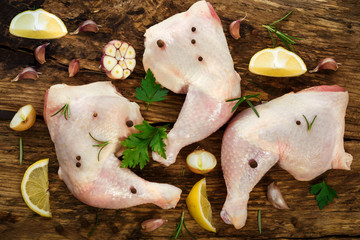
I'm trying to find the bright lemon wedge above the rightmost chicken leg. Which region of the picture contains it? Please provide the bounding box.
[249,47,307,77]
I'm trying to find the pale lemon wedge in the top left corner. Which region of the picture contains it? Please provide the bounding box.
[9,8,67,39]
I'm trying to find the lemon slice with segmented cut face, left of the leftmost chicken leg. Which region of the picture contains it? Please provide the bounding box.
[21,158,52,217]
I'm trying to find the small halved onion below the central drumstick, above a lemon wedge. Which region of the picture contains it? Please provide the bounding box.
[186,150,217,174]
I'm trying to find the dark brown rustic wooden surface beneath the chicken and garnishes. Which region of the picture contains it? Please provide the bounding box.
[0,0,360,239]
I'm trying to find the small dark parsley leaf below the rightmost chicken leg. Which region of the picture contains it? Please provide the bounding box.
[310,181,338,210]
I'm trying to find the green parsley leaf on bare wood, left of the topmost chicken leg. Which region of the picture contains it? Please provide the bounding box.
[135,68,169,110]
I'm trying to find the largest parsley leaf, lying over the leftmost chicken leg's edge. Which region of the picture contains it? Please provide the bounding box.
[120,120,167,169]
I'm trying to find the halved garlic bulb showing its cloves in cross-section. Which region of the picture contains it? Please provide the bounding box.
[101,40,136,79]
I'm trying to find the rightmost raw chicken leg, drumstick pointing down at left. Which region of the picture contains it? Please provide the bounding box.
[221,86,352,229]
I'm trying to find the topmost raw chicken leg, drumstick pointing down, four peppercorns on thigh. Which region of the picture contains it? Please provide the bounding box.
[143,1,240,166]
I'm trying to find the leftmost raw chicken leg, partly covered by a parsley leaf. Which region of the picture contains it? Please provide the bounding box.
[44,82,181,209]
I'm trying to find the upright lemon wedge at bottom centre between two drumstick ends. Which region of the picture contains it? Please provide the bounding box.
[186,178,216,232]
